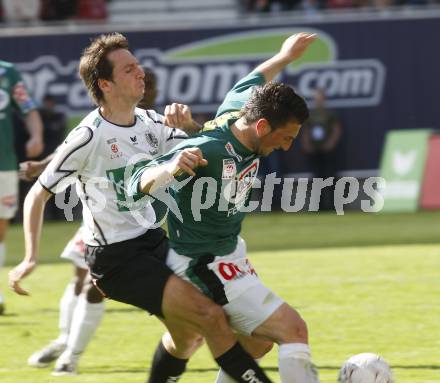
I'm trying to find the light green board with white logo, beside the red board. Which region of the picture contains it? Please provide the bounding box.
[381,129,431,212]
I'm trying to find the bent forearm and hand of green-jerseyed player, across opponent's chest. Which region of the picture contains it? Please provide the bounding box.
[138,148,208,193]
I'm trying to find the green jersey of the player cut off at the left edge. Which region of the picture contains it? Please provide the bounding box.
[0,61,35,171]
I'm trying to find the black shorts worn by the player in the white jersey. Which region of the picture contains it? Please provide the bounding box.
[85,228,173,317]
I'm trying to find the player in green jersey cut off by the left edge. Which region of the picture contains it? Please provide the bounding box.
[0,61,43,315]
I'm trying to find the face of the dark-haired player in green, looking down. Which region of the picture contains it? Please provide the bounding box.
[257,121,301,156]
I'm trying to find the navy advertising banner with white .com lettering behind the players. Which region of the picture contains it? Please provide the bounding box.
[0,18,440,173]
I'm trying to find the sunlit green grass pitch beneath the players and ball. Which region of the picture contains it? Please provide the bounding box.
[0,212,440,383]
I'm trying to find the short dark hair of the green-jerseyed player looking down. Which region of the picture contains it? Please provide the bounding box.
[240,81,309,129]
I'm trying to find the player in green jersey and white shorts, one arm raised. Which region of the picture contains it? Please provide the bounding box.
[130,33,318,383]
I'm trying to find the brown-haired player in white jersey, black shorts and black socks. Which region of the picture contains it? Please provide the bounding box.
[9,33,270,383]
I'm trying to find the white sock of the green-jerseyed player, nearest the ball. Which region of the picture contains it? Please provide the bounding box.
[278,343,319,383]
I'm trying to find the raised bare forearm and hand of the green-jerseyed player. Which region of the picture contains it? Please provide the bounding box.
[255,32,317,81]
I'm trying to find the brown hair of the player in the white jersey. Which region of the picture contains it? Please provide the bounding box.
[79,33,128,105]
